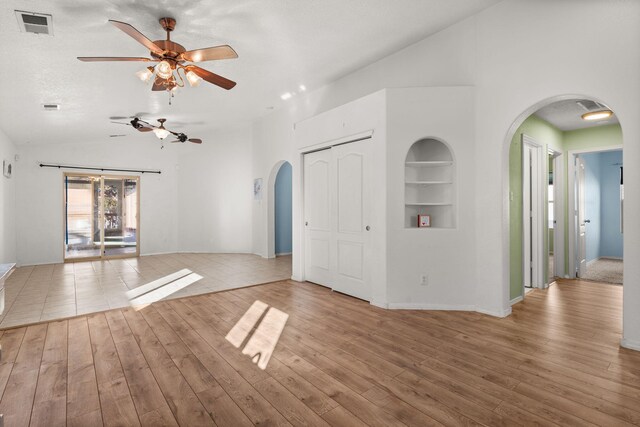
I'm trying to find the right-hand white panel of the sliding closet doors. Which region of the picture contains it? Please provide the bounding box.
[331,141,371,301]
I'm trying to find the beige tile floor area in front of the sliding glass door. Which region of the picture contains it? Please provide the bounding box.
[0,254,291,328]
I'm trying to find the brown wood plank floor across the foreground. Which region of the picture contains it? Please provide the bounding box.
[0,281,640,427]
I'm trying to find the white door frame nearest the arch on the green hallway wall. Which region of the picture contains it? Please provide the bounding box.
[522,134,548,296]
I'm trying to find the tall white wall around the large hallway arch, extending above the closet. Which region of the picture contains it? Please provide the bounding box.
[253,0,640,348]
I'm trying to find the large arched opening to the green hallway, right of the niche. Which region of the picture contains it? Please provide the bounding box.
[507,96,624,304]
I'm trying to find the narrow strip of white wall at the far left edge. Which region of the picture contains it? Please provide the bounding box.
[0,130,17,264]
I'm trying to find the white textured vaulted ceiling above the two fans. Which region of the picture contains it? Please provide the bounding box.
[0,0,498,145]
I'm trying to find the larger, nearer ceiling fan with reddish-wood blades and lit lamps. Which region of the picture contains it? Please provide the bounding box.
[78,18,238,91]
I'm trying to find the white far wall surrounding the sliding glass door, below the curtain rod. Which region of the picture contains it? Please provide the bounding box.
[16,123,251,265]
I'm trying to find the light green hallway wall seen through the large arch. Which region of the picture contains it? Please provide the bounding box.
[509,119,622,300]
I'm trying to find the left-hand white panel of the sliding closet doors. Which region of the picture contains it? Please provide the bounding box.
[304,149,333,286]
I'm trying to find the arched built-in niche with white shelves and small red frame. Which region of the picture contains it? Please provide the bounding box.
[404,138,456,228]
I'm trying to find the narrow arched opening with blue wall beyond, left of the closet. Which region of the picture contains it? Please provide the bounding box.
[266,160,293,258]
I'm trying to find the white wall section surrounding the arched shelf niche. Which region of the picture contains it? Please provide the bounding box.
[386,87,476,314]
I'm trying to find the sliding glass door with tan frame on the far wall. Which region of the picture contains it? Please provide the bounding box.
[64,174,140,260]
